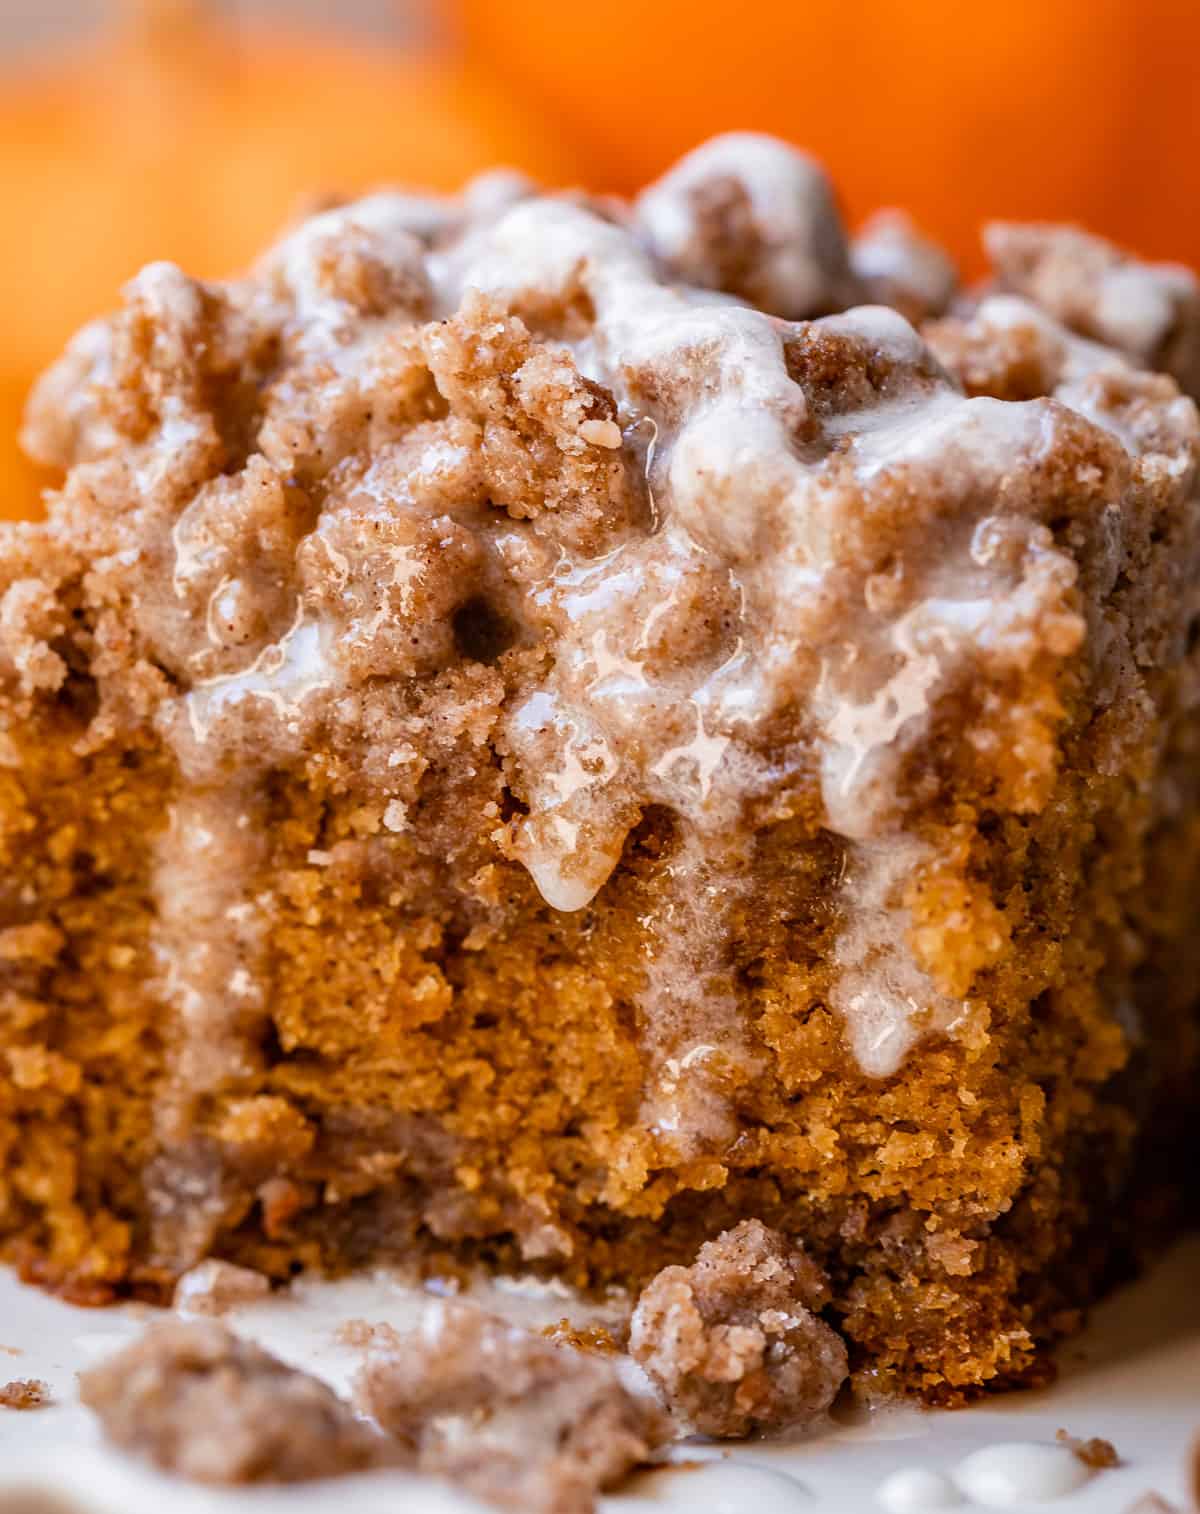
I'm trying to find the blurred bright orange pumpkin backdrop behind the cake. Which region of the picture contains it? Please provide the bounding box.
[0,0,1200,513]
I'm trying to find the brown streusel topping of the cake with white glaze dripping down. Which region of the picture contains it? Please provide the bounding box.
[3,136,1197,1131]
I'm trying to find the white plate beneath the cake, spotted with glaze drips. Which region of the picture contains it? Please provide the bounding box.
[0,1238,1200,1514]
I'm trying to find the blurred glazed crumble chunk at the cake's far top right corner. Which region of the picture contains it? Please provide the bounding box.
[984,221,1200,394]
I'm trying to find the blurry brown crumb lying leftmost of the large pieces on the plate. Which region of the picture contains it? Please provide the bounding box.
[79,1320,385,1484]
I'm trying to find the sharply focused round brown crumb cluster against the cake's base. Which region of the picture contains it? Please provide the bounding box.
[630,1220,849,1437]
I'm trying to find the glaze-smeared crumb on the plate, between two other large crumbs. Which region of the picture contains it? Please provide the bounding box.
[357,1299,669,1514]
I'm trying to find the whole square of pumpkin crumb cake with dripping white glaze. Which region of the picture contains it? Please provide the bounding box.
[0,136,1200,1400]
